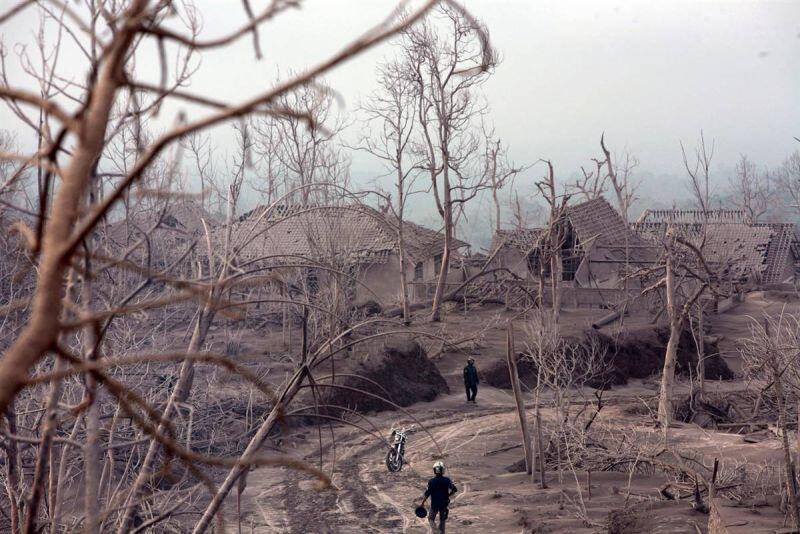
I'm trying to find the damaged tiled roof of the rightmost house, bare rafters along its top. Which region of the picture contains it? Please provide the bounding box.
[633,210,800,287]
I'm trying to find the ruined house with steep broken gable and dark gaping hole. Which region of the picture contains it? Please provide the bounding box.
[491,197,655,288]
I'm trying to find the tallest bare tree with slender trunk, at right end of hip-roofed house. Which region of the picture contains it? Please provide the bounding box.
[403,5,496,321]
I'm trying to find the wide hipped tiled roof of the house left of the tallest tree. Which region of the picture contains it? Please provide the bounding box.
[220,204,467,263]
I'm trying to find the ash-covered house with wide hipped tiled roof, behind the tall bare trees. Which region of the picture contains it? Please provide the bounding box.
[220,204,468,306]
